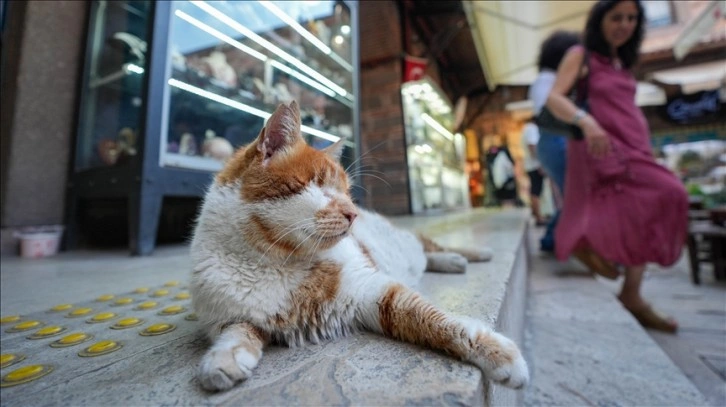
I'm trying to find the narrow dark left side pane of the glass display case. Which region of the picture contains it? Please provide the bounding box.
[75,1,151,171]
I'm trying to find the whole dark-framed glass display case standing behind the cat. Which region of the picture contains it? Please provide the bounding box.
[66,0,359,255]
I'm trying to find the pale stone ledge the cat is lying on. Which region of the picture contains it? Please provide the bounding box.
[0,210,527,405]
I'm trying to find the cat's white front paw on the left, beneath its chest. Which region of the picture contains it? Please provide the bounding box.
[197,347,259,391]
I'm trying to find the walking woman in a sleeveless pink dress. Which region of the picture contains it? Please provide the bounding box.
[547,0,688,332]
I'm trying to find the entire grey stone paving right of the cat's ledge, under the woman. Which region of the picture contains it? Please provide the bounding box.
[525,229,726,406]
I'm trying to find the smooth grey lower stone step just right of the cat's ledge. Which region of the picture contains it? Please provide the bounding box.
[524,232,707,406]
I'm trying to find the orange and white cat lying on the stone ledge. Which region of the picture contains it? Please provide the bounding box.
[191,102,529,390]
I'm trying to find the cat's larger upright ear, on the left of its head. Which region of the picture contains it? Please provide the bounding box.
[257,100,304,164]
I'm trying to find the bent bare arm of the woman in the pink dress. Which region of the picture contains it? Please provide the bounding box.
[547,47,610,157]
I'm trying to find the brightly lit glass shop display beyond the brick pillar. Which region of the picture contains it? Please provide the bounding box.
[401,78,470,213]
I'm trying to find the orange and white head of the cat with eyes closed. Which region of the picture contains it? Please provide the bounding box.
[217,102,358,254]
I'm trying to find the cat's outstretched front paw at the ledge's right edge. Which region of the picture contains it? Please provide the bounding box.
[470,328,529,389]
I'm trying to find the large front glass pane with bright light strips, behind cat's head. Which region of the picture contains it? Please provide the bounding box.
[160,1,356,171]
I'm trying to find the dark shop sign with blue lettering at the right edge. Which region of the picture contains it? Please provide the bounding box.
[664,89,722,124]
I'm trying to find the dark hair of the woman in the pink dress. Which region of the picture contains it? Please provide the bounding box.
[585,0,645,68]
